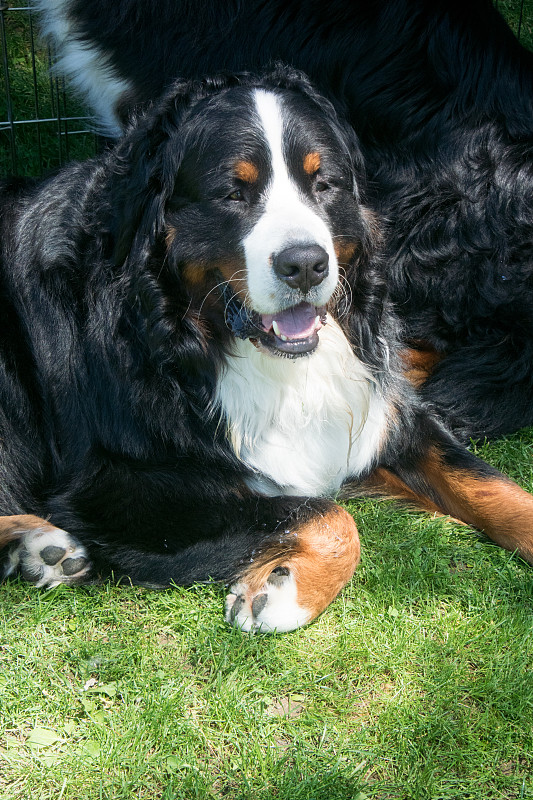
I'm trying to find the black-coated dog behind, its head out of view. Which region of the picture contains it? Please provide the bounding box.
[37,0,533,441]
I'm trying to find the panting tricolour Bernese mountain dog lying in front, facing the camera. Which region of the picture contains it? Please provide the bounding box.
[0,68,533,631]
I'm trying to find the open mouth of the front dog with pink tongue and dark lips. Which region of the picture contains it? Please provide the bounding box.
[222,290,327,358]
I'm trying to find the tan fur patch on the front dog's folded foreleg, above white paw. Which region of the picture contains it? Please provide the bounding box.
[235,503,361,619]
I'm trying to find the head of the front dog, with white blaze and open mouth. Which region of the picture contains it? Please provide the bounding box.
[113,69,378,357]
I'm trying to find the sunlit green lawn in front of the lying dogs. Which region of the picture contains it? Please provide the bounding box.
[0,0,533,800]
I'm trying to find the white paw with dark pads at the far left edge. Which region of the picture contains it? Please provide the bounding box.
[9,525,91,589]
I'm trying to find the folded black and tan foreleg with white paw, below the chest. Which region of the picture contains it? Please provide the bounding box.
[87,496,360,632]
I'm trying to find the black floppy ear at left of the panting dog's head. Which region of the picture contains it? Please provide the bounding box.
[111,75,245,264]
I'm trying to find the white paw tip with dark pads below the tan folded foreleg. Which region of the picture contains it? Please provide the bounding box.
[225,567,313,633]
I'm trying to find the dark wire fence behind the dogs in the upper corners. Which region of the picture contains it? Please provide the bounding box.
[0,0,533,175]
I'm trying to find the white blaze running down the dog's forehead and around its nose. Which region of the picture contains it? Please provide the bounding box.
[244,89,338,313]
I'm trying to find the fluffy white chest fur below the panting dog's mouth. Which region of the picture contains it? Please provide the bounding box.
[216,320,387,497]
